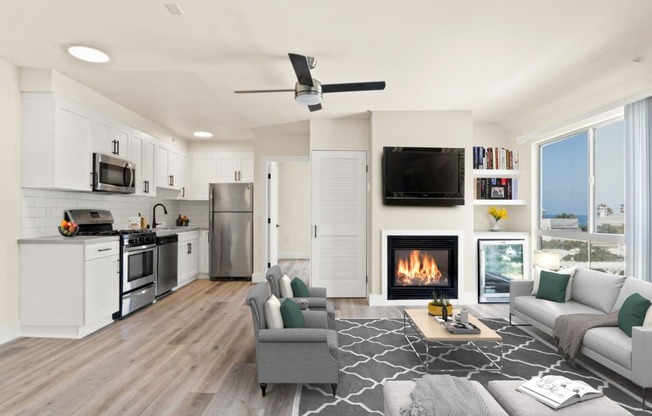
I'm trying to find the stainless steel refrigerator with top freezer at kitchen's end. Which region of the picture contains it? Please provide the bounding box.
[208,183,254,280]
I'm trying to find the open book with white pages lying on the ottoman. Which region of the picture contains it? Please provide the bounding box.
[516,376,603,409]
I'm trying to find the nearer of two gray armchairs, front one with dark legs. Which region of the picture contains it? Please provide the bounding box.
[247,283,339,396]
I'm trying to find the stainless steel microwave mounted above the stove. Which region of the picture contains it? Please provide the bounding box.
[93,153,136,194]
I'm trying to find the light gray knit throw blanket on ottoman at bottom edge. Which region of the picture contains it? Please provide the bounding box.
[401,374,489,416]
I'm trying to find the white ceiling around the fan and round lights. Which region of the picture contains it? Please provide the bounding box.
[0,0,652,139]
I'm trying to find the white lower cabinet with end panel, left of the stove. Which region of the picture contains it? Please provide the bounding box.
[20,239,120,338]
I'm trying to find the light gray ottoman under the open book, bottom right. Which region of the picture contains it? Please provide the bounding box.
[487,380,631,416]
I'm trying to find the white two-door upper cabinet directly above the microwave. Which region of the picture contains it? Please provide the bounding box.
[91,113,131,163]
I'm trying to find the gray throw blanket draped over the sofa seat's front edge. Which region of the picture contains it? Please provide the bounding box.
[552,311,618,365]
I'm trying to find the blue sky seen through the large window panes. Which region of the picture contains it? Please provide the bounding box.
[541,122,624,215]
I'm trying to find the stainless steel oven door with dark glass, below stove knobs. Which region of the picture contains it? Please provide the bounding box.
[122,244,157,294]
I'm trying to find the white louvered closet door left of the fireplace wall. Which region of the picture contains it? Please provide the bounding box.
[310,151,367,297]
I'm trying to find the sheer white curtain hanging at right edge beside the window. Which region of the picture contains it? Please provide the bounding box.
[625,97,652,281]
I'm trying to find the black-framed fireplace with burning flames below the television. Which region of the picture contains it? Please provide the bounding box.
[387,235,458,300]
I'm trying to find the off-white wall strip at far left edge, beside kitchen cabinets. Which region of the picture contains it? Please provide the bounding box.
[0,59,20,344]
